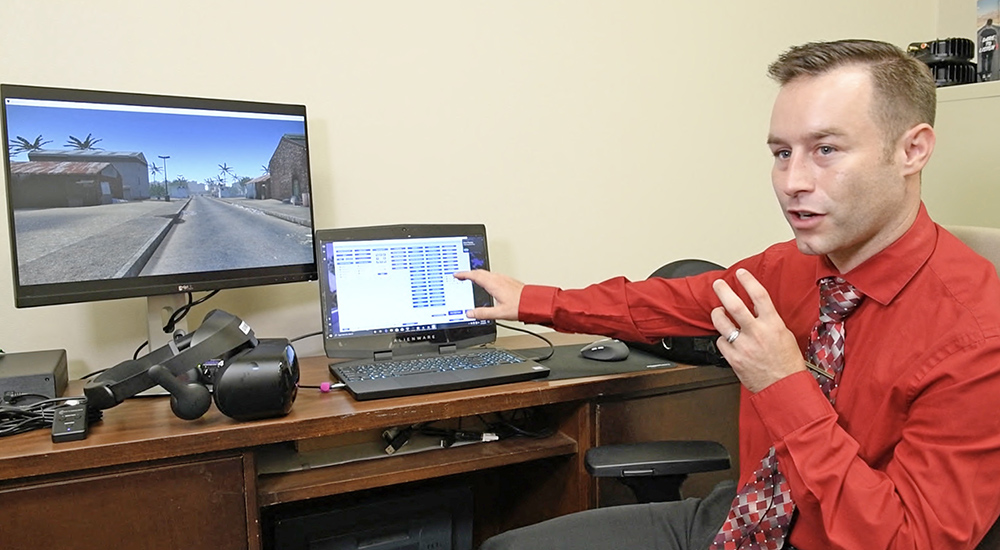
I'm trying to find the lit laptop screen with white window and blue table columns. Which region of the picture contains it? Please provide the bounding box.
[321,237,485,336]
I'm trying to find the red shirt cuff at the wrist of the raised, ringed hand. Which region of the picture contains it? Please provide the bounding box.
[750,371,836,441]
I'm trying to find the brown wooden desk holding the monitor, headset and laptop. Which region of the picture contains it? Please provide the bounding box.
[0,335,739,550]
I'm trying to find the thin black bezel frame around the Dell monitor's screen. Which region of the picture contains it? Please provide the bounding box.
[0,84,318,308]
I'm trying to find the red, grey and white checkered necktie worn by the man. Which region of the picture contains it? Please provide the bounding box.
[709,277,864,550]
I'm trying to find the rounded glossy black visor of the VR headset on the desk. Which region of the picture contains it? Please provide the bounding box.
[211,338,299,420]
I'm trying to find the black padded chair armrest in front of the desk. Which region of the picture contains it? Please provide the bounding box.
[584,441,730,477]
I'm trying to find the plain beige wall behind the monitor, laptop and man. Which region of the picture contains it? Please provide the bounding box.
[0,0,939,377]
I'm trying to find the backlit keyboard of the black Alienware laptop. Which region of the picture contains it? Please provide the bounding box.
[332,349,524,382]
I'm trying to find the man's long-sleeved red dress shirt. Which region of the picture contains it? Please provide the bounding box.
[519,206,1000,550]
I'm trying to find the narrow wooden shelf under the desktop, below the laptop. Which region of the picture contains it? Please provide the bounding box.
[257,432,578,507]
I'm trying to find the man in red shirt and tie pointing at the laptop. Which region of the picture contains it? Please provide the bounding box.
[456,40,1000,550]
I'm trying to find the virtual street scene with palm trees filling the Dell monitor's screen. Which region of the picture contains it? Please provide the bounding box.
[6,99,313,285]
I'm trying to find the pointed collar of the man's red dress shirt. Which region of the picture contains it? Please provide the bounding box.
[816,202,937,305]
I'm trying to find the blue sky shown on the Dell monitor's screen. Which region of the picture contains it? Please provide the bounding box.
[7,101,305,183]
